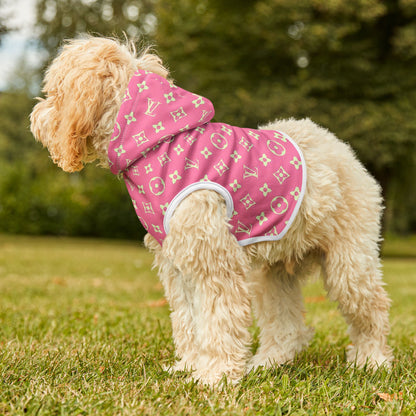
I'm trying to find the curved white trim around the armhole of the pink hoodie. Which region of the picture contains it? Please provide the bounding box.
[163,181,234,234]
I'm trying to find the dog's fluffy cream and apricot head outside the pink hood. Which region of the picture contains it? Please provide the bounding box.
[30,36,168,172]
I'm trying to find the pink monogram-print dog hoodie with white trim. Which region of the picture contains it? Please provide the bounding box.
[108,70,306,245]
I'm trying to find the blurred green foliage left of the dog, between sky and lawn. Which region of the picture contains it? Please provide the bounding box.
[0,92,144,239]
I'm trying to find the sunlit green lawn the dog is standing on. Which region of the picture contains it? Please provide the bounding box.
[0,235,416,415]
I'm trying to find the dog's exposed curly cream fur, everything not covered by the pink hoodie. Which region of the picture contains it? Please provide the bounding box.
[31,37,393,384]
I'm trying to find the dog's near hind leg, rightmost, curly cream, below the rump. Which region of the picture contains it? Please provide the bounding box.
[323,240,393,368]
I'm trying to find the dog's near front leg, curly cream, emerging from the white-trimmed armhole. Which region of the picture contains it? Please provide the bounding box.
[162,191,251,385]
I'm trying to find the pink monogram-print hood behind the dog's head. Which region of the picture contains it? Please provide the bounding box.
[108,70,215,175]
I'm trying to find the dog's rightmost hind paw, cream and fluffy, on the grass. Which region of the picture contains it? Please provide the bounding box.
[347,345,393,370]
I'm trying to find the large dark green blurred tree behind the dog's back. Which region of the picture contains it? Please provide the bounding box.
[156,0,416,231]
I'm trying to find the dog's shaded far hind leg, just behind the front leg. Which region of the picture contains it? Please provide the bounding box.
[249,263,313,369]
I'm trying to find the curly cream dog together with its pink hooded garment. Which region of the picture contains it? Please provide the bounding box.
[30,36,393,385]
